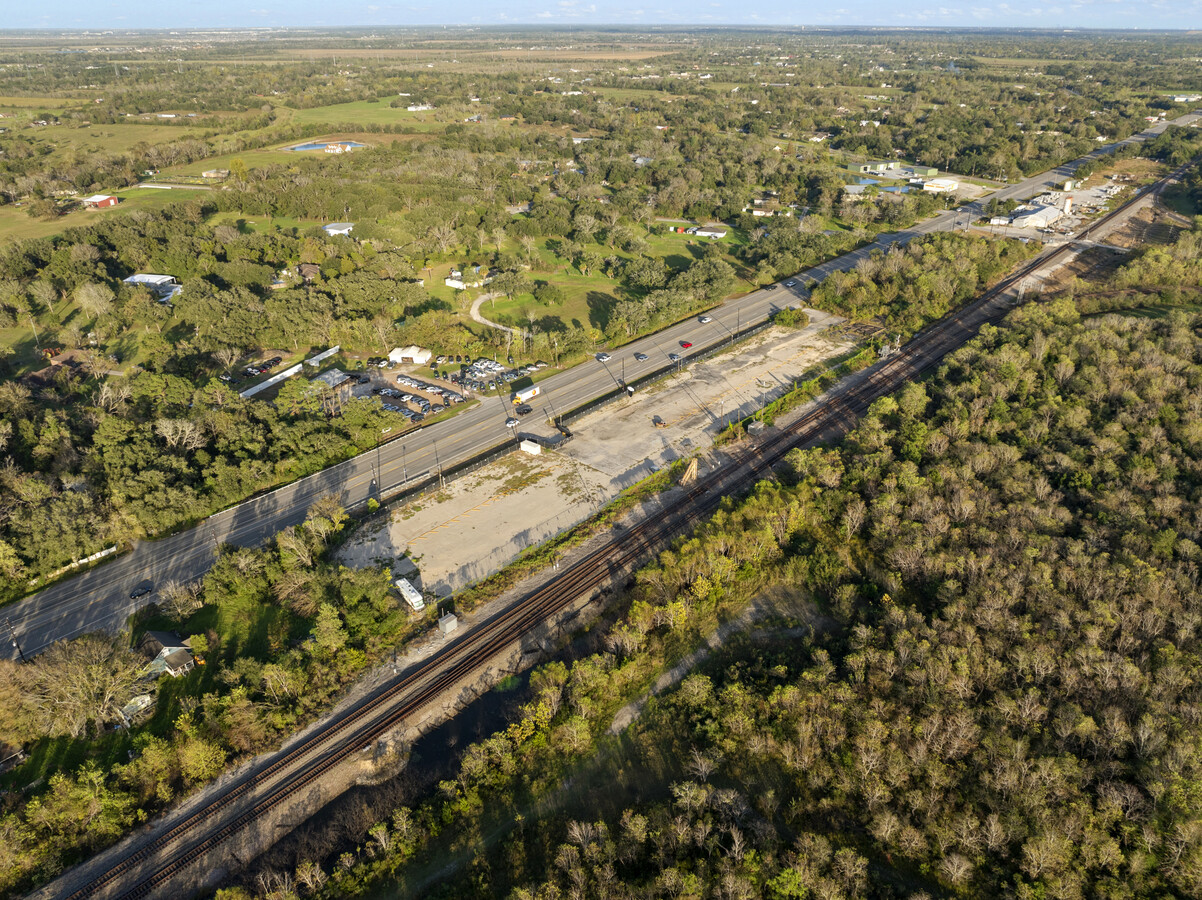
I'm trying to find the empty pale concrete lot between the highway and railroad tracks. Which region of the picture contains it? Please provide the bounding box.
[339,310,852,596]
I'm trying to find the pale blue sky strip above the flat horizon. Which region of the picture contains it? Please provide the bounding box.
[7,0,1202,30]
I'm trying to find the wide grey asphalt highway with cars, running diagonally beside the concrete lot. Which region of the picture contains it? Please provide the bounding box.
[0,114,1200,657]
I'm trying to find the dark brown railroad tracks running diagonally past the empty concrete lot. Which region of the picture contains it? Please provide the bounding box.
[54,157,1185,900]
